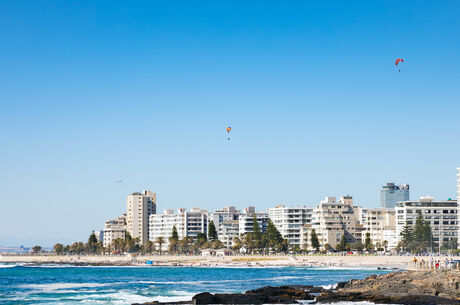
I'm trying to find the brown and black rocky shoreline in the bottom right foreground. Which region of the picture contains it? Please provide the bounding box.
[133,270,460,305]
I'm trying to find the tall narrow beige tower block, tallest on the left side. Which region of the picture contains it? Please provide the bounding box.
[126,191,157,244]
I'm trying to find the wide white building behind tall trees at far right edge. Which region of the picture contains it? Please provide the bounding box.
[395,197,459,247]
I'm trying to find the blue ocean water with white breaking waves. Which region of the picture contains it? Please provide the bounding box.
[0,264,388,305]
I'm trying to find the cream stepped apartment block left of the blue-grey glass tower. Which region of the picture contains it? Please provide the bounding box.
[302,195,363,250]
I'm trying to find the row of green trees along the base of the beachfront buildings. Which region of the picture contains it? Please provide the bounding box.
[17,214,459,255]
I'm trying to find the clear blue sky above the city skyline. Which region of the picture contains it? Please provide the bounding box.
[0,1,460,246]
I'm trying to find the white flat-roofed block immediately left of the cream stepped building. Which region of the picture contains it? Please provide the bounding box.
[267,205,313,248]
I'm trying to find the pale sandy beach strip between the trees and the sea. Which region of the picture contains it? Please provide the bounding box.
[0,255,413,268]
